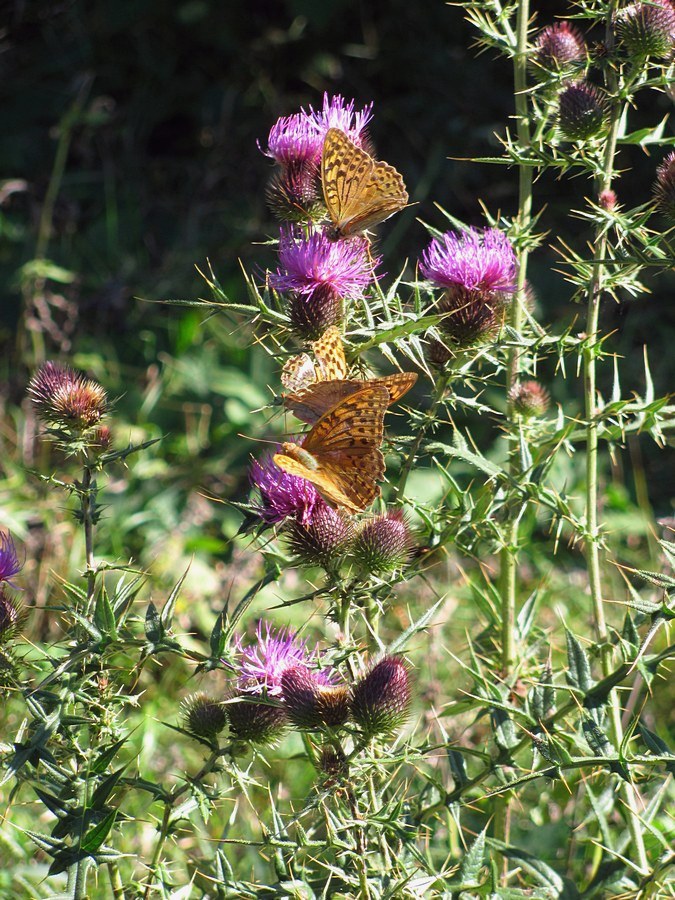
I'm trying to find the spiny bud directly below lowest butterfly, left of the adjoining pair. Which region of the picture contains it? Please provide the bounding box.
[285,499,353,570]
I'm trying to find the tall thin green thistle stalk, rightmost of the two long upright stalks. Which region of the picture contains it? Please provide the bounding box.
[582,6,649,873]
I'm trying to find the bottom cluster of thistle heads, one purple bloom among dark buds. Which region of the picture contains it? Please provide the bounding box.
[184,622,411,746]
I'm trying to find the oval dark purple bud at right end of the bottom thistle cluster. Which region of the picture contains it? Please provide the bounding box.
[352,656,412,737]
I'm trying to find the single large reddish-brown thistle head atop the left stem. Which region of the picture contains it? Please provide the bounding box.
[28,362,108,431]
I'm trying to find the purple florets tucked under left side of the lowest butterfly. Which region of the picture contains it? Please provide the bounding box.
[250,456,323,525]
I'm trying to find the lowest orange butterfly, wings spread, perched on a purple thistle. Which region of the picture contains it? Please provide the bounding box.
[274,385,389,512]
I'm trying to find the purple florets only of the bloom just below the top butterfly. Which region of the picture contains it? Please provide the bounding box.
[269,229,378,297]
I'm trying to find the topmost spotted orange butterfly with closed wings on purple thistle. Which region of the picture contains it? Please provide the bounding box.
[321,128,408,239]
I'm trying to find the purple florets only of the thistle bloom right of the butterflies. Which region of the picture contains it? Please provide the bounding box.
[420,228,517,294]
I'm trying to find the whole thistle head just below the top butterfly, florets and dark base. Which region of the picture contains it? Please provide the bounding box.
[269,229,375,340]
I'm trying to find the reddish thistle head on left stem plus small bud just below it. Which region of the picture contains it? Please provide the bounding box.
[28,362,112,454]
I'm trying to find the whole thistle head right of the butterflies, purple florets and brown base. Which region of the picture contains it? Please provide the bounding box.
[420,228,517,363]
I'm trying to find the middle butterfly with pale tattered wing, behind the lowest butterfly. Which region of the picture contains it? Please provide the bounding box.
[281,325,417,425]
